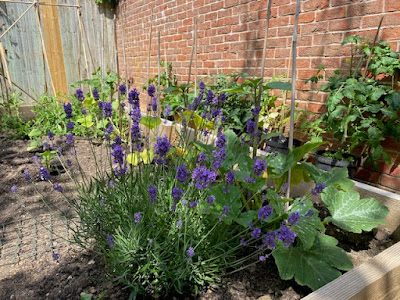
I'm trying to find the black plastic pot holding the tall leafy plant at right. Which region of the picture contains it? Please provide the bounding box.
[315,150,361,178]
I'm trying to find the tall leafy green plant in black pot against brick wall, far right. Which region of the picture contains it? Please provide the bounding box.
[303,36,400,175]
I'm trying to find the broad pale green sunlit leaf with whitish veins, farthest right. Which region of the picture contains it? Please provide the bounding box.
[321,187,389,233]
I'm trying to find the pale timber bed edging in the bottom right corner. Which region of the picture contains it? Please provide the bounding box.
[303,243,400,300]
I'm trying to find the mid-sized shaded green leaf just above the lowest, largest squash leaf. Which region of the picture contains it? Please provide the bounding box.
[290,199,325,249]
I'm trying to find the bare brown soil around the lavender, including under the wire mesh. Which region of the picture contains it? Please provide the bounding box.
[0,136,394,300]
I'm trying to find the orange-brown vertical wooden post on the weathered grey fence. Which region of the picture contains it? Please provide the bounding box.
[40,0,68,94]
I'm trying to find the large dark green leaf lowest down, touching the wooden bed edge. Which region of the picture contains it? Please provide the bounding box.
[272,235,353,290]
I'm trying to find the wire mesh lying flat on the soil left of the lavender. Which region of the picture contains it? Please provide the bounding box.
[0,214,70,266]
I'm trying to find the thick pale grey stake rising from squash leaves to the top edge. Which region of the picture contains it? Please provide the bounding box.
[285,0,300,206]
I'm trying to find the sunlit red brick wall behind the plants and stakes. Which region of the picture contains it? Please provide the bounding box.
[117,0,400,190]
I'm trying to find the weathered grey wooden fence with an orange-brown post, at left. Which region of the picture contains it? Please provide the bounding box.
[0,0,117,105]
